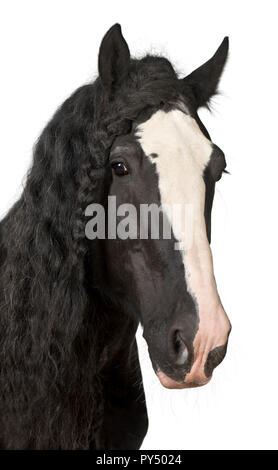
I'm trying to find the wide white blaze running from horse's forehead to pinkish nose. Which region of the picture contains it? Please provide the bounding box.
[138,110,229,374]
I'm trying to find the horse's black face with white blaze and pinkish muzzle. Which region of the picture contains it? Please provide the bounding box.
[96,23,231,388]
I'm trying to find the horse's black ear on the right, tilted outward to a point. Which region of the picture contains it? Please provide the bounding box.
[183,37,229,108]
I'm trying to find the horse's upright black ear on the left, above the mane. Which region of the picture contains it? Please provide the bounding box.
[98,23,130,96]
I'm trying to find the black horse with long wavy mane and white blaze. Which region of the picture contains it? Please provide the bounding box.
[0,24,231,450]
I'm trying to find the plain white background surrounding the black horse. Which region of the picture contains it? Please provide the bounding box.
[0,0,278,449]
